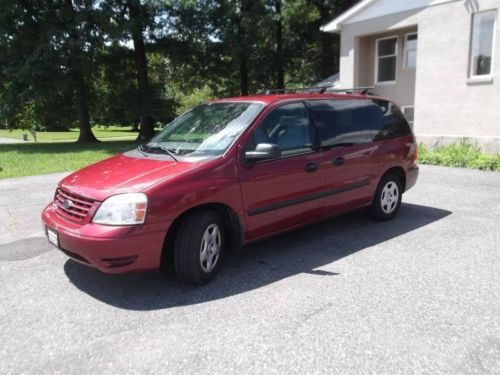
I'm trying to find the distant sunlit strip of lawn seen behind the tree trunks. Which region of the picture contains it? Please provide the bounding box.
[0,126,137,142]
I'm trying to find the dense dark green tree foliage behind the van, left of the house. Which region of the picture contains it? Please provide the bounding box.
[0,0,356,142]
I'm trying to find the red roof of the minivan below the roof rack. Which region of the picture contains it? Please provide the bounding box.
[211,93,386,105]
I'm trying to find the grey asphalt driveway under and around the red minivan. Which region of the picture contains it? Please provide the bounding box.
[0,166,500,374]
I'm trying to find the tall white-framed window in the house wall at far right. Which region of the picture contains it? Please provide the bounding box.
[469,10,497,78]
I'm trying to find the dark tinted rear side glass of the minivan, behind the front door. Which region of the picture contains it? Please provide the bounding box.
[309,99,411,147]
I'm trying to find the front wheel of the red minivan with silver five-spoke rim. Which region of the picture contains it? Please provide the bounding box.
[174,211,225,285]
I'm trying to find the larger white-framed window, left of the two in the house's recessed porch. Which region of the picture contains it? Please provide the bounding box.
[375,37,398,84]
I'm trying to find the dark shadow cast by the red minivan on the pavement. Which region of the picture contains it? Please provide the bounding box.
[64,204,451,310]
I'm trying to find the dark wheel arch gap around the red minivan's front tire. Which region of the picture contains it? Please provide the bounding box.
[161,202,244,268]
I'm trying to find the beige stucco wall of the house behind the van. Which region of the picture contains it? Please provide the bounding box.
[340,0,500,144]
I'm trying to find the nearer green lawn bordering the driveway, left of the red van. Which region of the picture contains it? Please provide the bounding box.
[0,140,137,179]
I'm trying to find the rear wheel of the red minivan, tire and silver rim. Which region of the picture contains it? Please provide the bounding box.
[369,174,403,221]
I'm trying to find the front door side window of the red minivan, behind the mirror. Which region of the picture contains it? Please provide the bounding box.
[248,102,312,156]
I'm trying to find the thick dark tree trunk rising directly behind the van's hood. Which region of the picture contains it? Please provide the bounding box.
[129,2,155,142]
